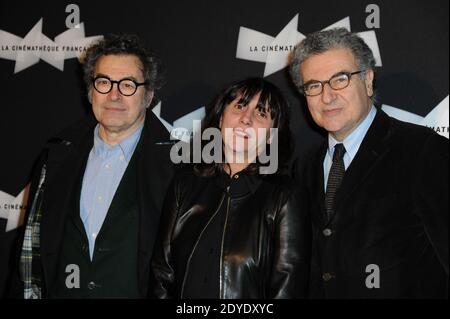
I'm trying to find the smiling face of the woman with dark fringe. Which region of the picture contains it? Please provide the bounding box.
[220,92,273,163]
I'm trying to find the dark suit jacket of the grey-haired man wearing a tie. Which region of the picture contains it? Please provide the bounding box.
[302,110,449,298]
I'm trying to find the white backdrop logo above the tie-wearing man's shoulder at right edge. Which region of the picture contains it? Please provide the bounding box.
[382,95,449,138]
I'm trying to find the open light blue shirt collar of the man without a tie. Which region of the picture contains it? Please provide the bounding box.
[93,124,144,162]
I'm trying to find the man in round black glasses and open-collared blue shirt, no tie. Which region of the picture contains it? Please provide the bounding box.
[10,35,173,298]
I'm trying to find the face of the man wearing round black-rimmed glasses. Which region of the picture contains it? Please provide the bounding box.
[91,55,153,134]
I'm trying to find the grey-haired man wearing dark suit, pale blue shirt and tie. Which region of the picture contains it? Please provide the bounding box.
[290,29,449,298]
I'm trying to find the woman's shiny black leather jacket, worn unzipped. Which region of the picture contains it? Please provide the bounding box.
[152,169,311,299]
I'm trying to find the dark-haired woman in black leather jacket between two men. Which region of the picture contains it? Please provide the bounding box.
[152,78,310,299]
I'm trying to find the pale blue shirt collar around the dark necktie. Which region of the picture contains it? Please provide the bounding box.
[328,105,377,159]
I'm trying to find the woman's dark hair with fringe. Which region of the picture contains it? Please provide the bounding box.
[194,78,293,176]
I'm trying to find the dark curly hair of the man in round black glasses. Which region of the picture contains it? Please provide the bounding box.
[82,34,163,106]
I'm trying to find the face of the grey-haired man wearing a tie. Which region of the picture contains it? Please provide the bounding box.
[300,48,373,141]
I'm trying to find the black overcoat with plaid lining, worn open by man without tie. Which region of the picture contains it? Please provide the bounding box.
[12,111,174,297]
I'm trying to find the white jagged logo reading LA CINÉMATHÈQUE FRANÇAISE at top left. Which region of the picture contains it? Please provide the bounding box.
[0,18,103,73]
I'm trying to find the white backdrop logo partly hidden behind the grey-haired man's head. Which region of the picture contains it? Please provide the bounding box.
[236,14,382,77]
